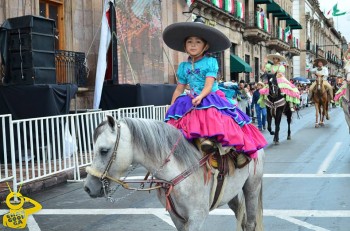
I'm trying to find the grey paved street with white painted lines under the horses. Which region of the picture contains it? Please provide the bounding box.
[0,107,350,231]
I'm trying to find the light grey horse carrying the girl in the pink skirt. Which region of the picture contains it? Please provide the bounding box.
[84,116,265,231]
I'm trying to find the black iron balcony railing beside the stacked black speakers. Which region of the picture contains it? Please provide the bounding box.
[55,50,87,87]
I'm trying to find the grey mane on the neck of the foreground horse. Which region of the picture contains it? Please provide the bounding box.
[122,118,201,167]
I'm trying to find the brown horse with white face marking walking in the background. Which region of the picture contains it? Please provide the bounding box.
[312,78,329,128]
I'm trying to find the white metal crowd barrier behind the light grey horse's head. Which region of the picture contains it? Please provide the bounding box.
[0,106,166,191]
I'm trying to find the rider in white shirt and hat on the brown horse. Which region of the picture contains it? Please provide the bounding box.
[309,58,334,103]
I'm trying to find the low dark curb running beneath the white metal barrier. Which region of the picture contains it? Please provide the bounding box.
[0,168,87,202]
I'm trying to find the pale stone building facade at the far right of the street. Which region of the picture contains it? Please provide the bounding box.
[293,0,347,78]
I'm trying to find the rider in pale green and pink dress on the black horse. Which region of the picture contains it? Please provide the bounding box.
[260,53,300,111]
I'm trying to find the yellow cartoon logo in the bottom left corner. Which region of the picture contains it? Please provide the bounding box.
[2,184,42,229]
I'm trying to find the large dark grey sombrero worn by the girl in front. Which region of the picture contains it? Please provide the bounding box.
[163,22,231,52]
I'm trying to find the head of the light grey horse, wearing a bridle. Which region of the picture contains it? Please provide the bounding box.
[84,116,132,198]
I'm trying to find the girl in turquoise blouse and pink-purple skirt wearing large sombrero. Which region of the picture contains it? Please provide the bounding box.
[163,19,267,168]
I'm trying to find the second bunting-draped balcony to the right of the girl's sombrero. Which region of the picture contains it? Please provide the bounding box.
[243,12,271,43]
